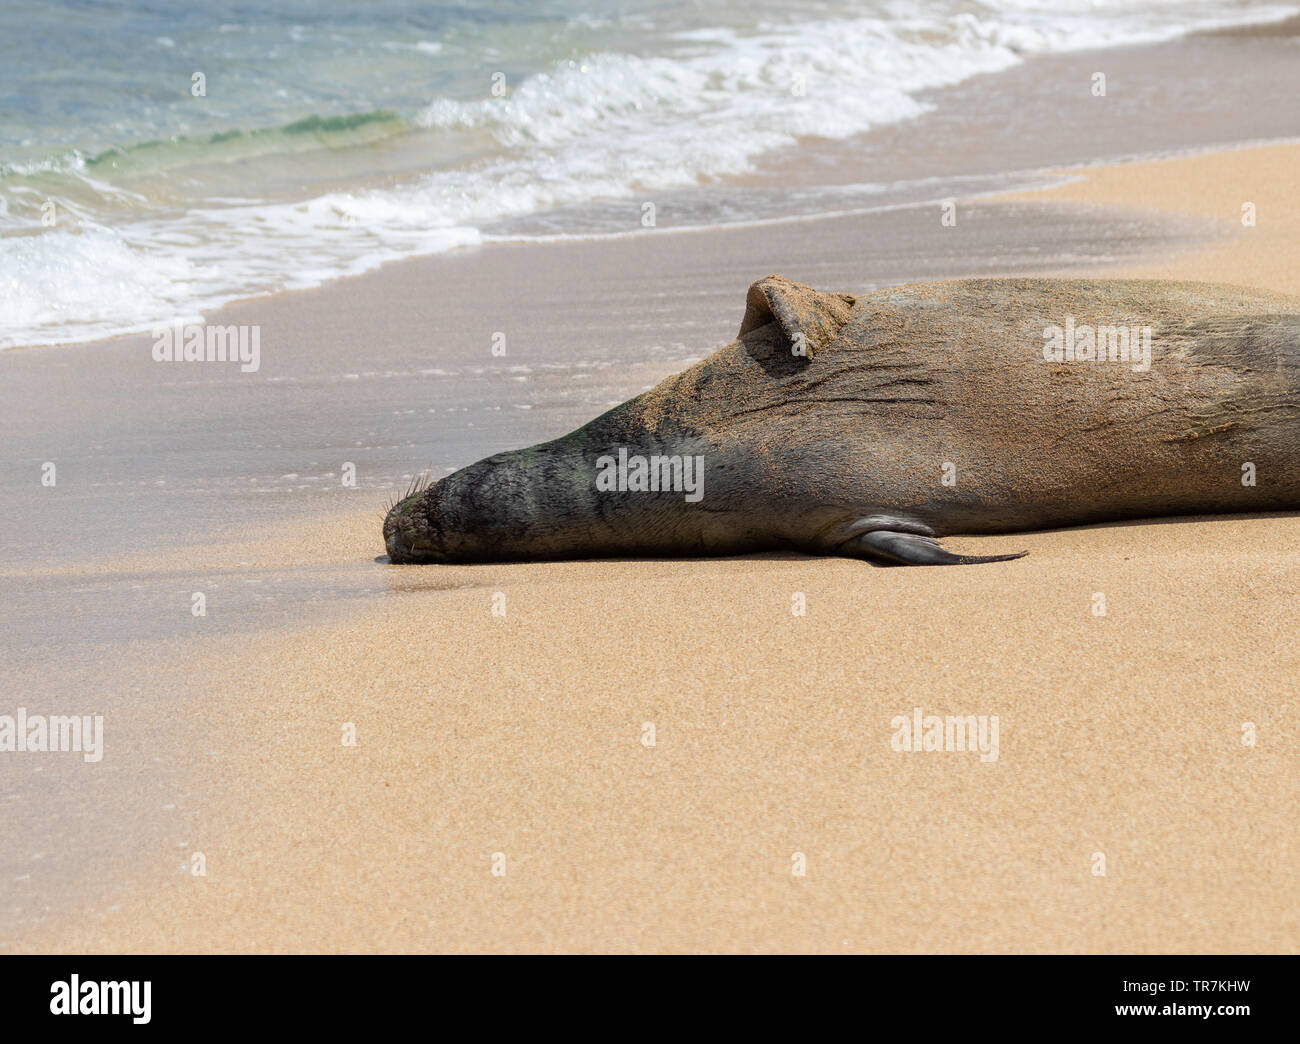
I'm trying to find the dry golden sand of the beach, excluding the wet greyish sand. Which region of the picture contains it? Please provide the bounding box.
[18,146,1300,952]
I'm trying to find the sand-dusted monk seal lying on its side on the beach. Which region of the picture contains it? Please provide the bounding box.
[384,276,1300,564]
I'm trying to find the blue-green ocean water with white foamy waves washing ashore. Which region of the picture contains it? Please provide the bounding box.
[0,0,1300,347]
